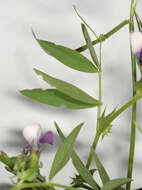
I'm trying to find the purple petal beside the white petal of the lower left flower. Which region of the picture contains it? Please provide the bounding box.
[39,131,54,144]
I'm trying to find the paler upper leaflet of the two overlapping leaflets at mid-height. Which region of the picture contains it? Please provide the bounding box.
[34,69,101,106]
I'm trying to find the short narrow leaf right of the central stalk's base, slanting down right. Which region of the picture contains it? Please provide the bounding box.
[93,152,110,184]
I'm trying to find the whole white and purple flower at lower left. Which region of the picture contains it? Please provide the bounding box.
[23,123,54,152]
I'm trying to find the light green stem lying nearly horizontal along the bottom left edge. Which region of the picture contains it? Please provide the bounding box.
[11,182,80,190]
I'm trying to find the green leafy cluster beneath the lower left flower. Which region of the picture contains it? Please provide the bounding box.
[0,148,44,186]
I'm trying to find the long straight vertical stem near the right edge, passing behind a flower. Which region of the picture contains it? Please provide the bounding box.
[126,0,136,190]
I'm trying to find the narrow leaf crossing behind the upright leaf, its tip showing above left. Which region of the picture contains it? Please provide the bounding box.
[55,122,99,189]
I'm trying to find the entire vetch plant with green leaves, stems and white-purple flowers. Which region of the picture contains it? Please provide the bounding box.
[0,0,142,190]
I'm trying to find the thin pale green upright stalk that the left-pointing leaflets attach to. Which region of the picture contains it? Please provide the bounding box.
[86,43,102,168]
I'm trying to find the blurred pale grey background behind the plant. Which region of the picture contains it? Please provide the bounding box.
[0,0,142,189]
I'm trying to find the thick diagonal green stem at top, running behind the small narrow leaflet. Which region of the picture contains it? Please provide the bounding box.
[76,19,129,52]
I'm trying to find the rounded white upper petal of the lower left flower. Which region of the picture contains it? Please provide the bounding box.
[23,124,41,144]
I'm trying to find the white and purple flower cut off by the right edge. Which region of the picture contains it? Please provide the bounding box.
[131,32,142,66]
